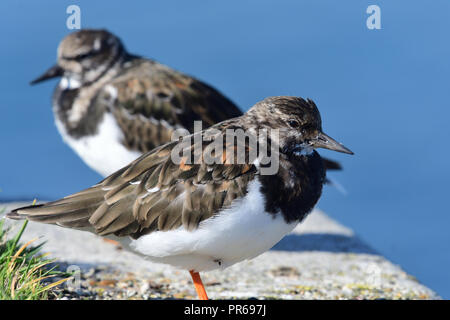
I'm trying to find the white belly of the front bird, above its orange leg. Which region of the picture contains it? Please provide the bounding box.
[129,180,297,272]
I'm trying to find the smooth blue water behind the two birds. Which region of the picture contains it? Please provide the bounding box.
[0,0,450,298]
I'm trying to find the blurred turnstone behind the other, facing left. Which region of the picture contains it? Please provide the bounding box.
[31,29,341,177]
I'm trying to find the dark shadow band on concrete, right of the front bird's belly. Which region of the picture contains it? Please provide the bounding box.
[271,233,378,254]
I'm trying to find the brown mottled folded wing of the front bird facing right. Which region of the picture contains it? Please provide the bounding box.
[9,126,256,238]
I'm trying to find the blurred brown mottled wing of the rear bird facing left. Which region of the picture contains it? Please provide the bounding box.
[96,58,242,152]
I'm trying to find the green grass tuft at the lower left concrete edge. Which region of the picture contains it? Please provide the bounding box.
[0,205,69,300]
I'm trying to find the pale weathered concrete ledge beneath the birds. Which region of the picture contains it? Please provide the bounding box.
[0,203,439,299]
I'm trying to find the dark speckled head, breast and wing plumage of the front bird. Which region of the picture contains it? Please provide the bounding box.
[10,97,350,238]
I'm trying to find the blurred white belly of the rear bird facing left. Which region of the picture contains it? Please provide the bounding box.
[55,112,141,177]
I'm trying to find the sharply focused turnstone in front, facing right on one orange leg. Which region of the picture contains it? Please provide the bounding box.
[7,96,353,300]
